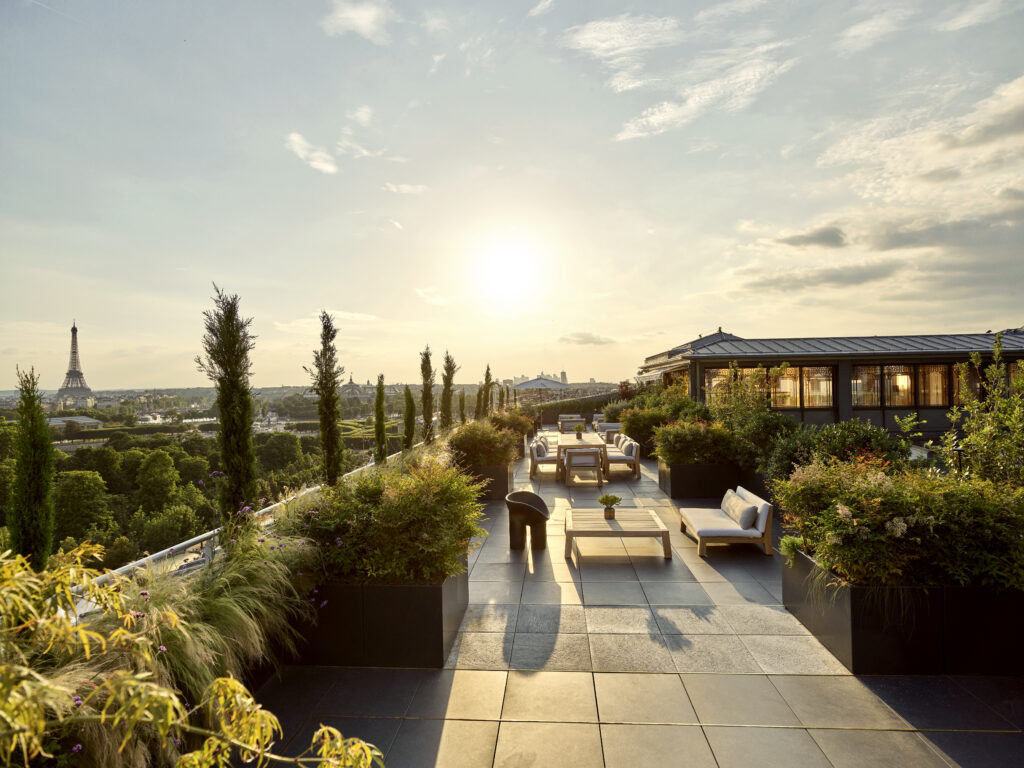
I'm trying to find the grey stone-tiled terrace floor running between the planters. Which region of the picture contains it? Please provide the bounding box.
[259,436,1024,768]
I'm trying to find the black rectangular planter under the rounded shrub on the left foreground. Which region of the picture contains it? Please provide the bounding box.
[296,573,469,668]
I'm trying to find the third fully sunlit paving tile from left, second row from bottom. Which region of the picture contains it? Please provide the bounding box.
[680,674,800,726]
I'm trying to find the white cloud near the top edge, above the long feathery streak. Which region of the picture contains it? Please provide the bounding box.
[561,13,683,93]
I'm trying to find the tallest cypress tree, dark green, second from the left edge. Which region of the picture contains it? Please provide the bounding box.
[196,284,256,542]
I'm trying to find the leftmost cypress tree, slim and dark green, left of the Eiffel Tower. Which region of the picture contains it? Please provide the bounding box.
[7,368,53,570]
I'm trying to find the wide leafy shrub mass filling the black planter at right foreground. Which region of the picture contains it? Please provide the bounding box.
[774,460,1024,589]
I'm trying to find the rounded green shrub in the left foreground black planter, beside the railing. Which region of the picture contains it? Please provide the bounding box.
[281,450,483,584]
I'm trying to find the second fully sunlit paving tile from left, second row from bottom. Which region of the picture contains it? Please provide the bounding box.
[594,673,697,724]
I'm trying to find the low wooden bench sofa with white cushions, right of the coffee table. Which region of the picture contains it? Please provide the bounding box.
[679,485,772,557]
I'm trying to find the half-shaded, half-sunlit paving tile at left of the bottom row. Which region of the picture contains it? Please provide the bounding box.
[385,720,499,768]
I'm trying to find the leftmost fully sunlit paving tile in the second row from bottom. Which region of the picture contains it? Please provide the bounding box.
[502,671,597,723]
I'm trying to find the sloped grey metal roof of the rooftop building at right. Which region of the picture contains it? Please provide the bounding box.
[671,334,1024,359]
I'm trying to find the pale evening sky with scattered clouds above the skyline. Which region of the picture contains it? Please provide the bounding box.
[0,0,1024,389]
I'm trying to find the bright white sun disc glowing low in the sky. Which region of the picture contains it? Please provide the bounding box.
[467,228,545,313]
